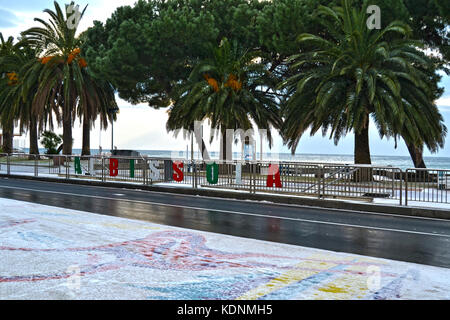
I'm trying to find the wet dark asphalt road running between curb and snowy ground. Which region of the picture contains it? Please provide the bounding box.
[0,178,450,268]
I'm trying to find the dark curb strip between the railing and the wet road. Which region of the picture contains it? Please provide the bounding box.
[0,174,450,220]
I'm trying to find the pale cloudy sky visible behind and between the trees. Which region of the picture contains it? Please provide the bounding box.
[0,0,450,157]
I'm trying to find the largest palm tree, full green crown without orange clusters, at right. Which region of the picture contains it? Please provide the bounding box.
[280,0,446,168]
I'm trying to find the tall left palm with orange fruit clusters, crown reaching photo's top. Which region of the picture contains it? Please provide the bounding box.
[23,1,116,155]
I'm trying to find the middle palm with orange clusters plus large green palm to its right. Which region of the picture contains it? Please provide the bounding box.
[167,0,447,167]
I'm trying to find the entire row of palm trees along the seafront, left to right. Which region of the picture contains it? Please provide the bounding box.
[0,0,447,167]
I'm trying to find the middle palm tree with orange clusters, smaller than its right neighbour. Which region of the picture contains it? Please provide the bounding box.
[167,38,281,160]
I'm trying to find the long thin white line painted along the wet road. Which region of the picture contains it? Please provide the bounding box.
[0,186,450,238]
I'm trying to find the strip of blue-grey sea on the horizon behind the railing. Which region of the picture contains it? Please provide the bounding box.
[23,149,450,170]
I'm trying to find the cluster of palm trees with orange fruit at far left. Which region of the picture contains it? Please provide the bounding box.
[0,1,117,155]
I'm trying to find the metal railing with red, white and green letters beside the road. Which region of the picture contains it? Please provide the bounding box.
[0,154,450,209]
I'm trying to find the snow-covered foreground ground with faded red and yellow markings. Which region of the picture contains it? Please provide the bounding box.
[0,199,450,300]
